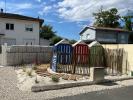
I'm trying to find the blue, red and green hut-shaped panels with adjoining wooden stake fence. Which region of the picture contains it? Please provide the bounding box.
[51,42,129,75]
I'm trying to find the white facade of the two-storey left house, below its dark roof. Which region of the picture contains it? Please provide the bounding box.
[0,18,39,45]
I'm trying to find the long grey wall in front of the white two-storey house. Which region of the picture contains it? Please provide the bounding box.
[0,45,52,66]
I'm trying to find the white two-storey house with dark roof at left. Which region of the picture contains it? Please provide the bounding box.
[0,10,44,45]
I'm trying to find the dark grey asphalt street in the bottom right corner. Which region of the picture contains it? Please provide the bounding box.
[52,86,133,100]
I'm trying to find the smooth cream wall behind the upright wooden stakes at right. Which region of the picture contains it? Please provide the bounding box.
[102,44,133,71]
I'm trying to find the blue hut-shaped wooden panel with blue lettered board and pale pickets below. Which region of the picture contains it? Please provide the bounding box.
[52,43,73,73]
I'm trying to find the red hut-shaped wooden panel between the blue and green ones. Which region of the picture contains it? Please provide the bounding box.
[73,41,90,75]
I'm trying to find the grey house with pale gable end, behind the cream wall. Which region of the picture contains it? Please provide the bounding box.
[79,26,133,44]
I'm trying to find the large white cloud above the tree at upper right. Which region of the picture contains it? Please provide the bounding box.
[58,0,133,21]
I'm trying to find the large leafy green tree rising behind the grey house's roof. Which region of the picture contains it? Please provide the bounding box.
[93,8,120,28]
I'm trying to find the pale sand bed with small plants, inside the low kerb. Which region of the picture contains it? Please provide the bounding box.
[15,68,129,91]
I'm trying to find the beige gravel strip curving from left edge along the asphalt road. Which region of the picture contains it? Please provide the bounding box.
[0,67,133,100]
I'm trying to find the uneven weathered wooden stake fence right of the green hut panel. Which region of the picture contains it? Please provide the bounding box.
[105,49,128,75]
